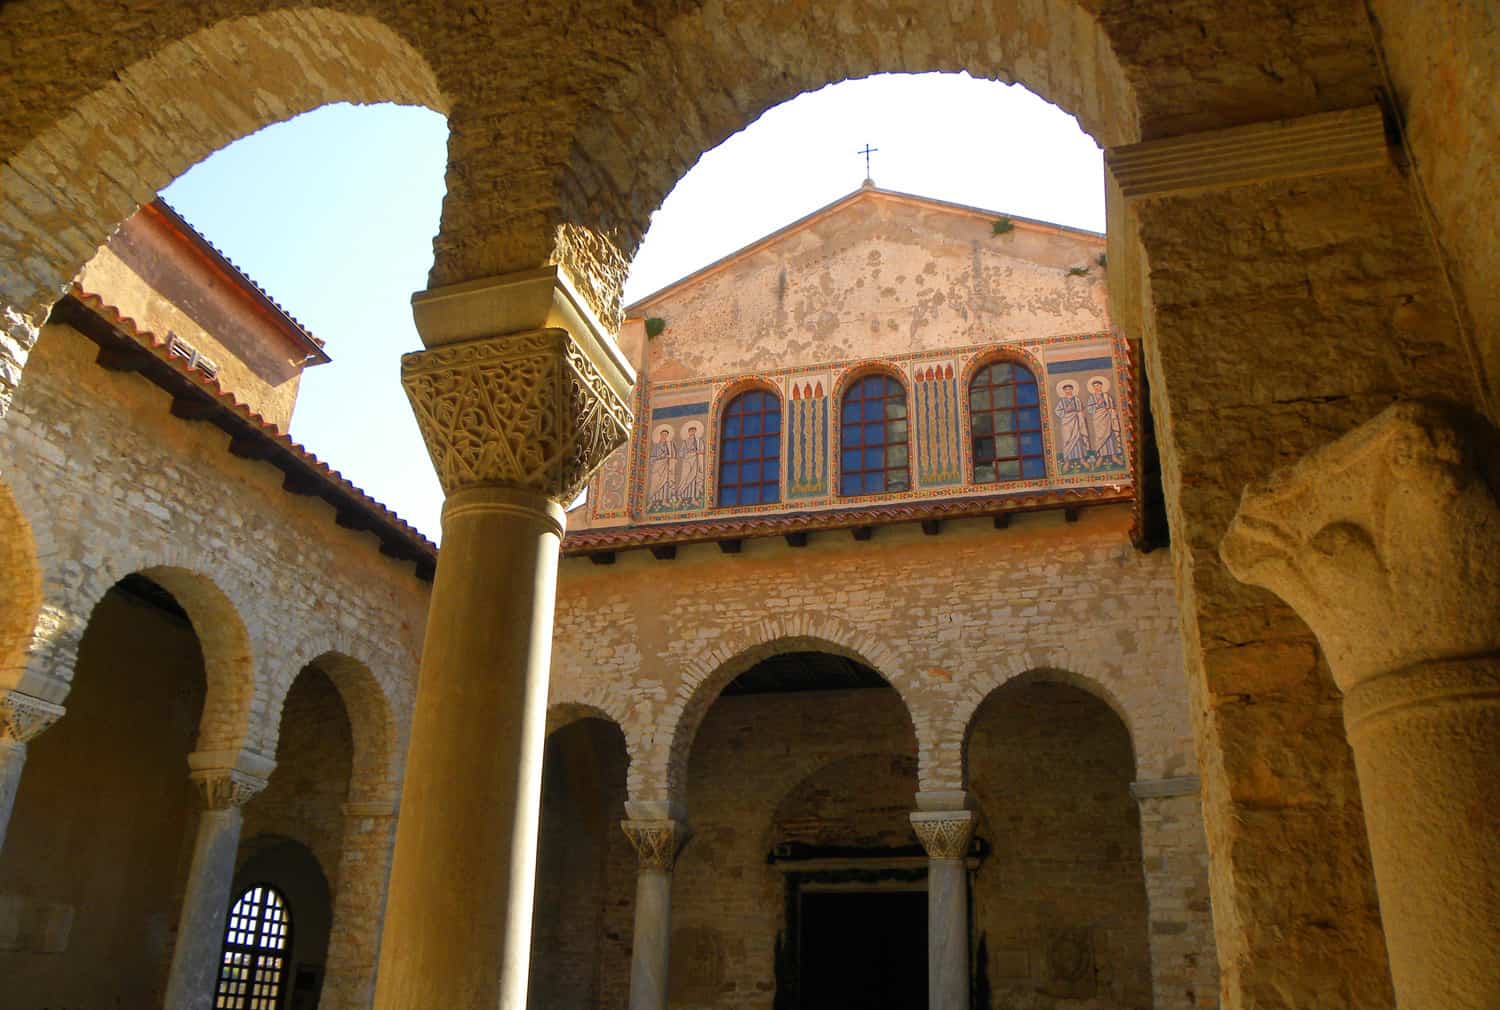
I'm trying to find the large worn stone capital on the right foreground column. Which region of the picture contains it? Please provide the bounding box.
[1220,402,1500,692]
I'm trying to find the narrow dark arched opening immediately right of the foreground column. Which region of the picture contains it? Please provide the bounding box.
[527,711,636,1010]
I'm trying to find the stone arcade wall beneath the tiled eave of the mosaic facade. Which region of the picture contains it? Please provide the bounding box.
[552,507,1217,1010]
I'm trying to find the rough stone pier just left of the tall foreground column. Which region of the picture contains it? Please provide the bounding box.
[318,800,396,1010]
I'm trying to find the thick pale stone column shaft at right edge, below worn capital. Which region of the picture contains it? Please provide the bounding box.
[1344,656,1500,1010]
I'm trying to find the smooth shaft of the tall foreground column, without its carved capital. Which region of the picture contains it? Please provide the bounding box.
[375,486,563,1010]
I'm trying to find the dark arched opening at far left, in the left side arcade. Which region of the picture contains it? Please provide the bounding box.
[0,572,214,1007]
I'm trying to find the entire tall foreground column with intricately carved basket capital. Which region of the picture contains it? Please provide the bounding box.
[375,269,633,1010]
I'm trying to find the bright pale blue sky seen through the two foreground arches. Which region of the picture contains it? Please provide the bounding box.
[162,74,1104,539]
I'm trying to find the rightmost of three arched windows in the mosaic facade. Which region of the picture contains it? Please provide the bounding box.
[969,362,1047,483]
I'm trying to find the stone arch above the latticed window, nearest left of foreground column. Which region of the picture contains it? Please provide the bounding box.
[265,647,410,807]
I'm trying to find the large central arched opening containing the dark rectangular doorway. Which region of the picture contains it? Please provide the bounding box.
[668,651,927,1010]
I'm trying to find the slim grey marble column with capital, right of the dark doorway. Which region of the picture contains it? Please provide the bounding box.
[912,794,974,1010]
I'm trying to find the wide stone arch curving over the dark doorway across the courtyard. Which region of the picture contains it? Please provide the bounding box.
[645,614,930,801]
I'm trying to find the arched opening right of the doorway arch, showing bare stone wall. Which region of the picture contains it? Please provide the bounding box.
[966,677,1146,1007]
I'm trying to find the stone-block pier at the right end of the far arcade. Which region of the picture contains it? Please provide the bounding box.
[1130,776,1218,1010]
